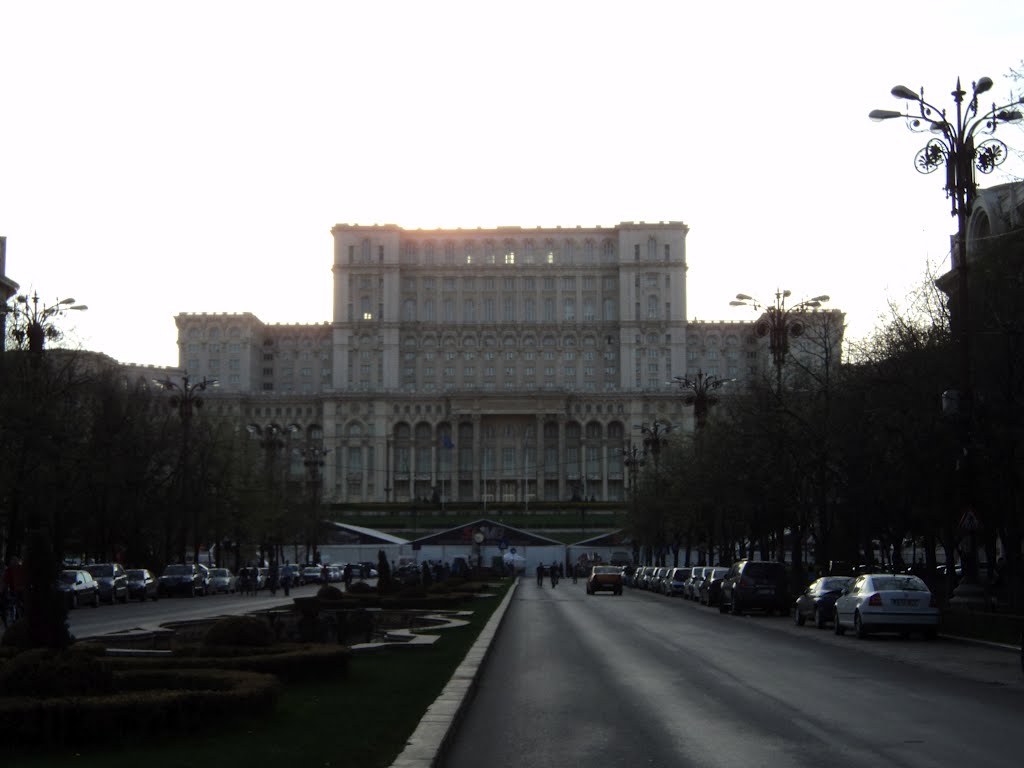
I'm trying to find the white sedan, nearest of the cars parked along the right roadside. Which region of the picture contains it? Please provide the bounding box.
[834,573,939,640]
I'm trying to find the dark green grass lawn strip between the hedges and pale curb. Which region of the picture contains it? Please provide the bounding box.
[8,582,509,768]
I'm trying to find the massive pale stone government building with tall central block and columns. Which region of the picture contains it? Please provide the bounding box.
[175,221,842,505]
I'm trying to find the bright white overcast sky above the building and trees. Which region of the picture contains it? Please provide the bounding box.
[0,0,1024,365]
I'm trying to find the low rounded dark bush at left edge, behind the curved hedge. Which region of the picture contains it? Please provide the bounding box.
[0,648,114,697]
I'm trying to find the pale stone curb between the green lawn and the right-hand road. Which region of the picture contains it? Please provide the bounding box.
[391,578,519,768]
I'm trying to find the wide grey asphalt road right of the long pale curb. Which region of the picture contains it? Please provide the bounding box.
[442,580,1024,768]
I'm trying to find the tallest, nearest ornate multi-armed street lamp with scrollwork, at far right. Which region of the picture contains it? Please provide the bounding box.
[868,77,1024,599]
